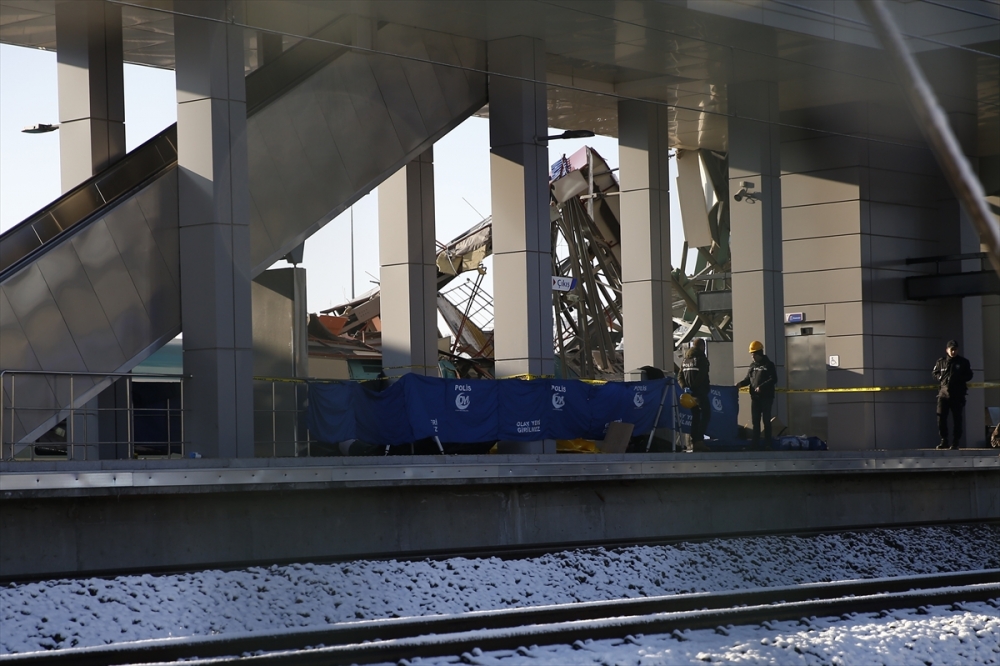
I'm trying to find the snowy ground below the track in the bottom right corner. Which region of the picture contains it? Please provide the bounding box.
[399,600,1000,666]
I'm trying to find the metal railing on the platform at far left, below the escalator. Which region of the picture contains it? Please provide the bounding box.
[0,370,186,461]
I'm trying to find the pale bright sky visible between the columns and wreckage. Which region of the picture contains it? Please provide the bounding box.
[0,44,684,312]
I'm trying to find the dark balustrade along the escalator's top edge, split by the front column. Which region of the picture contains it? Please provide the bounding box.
[0,16,353,282]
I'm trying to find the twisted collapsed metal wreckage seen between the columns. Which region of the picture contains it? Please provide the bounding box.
[310,146,732,380]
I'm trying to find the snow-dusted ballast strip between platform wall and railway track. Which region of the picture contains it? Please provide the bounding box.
[0,526,1000,653]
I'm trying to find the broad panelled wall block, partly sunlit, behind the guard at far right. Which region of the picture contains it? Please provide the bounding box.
[782,97,963,449]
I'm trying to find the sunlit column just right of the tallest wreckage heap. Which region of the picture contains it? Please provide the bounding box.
[618,102,673,373]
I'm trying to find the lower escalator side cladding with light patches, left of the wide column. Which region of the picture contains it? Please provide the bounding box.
[0,170,180,442]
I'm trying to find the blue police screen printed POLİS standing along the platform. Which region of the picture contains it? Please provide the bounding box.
[308,374,738,446]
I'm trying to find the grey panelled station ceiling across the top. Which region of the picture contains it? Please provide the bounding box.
[0,0,1000,156]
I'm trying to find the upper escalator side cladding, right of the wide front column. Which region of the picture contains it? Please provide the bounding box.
[247,26,486,275]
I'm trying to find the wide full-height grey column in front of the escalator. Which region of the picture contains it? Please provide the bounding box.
[174,0,253,458]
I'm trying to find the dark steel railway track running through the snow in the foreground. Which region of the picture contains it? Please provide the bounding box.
[0,569,1000,666]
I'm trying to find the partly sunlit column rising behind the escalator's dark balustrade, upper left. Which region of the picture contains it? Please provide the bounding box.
[56,0,125,192]
